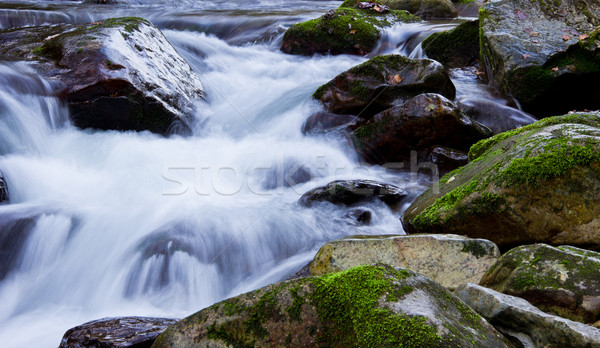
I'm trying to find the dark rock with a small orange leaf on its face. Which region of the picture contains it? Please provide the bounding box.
[313,55,456,119]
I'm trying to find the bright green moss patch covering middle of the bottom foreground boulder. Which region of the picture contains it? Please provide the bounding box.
[312,266,441,347]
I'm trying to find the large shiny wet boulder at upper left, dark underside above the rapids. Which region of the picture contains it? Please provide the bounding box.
[0,17,204,134]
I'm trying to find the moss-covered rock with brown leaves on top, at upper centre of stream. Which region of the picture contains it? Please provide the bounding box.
[281,7,419,55]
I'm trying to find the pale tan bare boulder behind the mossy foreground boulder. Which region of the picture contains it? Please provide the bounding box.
[310,235,500,289]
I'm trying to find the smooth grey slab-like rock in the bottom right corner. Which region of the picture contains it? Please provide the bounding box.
[454,284,600,348]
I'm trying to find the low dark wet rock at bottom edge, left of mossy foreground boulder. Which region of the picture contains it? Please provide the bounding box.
[59,317,178,348]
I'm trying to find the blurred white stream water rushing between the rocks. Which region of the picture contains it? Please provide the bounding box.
[0,0,520,347]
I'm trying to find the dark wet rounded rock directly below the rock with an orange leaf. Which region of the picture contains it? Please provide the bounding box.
[353,93,492,163]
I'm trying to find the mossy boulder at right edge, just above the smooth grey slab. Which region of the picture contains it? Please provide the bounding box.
[480,244,600,323]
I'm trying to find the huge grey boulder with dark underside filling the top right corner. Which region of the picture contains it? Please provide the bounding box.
[479,0,600,117]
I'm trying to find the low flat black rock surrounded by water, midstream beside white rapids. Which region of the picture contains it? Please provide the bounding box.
[300,180,408,208]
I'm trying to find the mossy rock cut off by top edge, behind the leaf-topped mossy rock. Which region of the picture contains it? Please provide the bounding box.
[342,0,458,19]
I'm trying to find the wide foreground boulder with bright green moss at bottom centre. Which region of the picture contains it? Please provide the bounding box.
[152,266,506,348]
